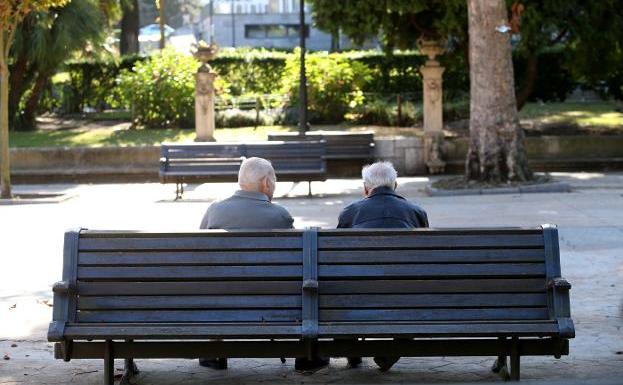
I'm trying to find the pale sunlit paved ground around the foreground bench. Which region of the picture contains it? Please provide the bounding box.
[0,173,623,385]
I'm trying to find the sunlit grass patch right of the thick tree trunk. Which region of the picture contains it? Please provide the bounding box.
[519,102,623,127]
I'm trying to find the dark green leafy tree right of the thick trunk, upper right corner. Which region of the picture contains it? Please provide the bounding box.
[512,0,623,109]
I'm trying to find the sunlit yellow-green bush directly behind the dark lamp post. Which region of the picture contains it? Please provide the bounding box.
[282,50,372,123]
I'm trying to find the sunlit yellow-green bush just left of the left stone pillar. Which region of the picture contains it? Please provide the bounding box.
[119,49,199,128]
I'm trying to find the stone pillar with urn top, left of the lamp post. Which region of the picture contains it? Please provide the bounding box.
[195,43,217,142]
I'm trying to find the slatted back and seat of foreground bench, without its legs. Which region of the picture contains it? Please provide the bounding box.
[54,227,573,338]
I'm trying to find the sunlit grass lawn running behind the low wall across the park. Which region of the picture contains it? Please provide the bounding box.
[9,102,623,147]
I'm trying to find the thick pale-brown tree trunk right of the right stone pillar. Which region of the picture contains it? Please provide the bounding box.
[465,0,532,182]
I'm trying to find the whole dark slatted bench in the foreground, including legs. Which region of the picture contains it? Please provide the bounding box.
[48,226,574,385]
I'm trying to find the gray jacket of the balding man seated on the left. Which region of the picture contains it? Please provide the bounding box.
[200,190,294,230]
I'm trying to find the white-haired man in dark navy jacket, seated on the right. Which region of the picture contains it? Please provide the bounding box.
[337,162,428,372]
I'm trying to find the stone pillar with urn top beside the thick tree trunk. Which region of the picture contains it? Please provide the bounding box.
[418,39,446,174]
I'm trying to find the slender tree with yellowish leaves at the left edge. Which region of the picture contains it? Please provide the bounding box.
[0,0,69,199]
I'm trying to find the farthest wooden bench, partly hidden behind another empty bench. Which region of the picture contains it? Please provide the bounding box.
[268,132,374,161]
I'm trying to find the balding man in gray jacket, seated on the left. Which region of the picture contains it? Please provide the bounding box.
[199,158,294,369]
